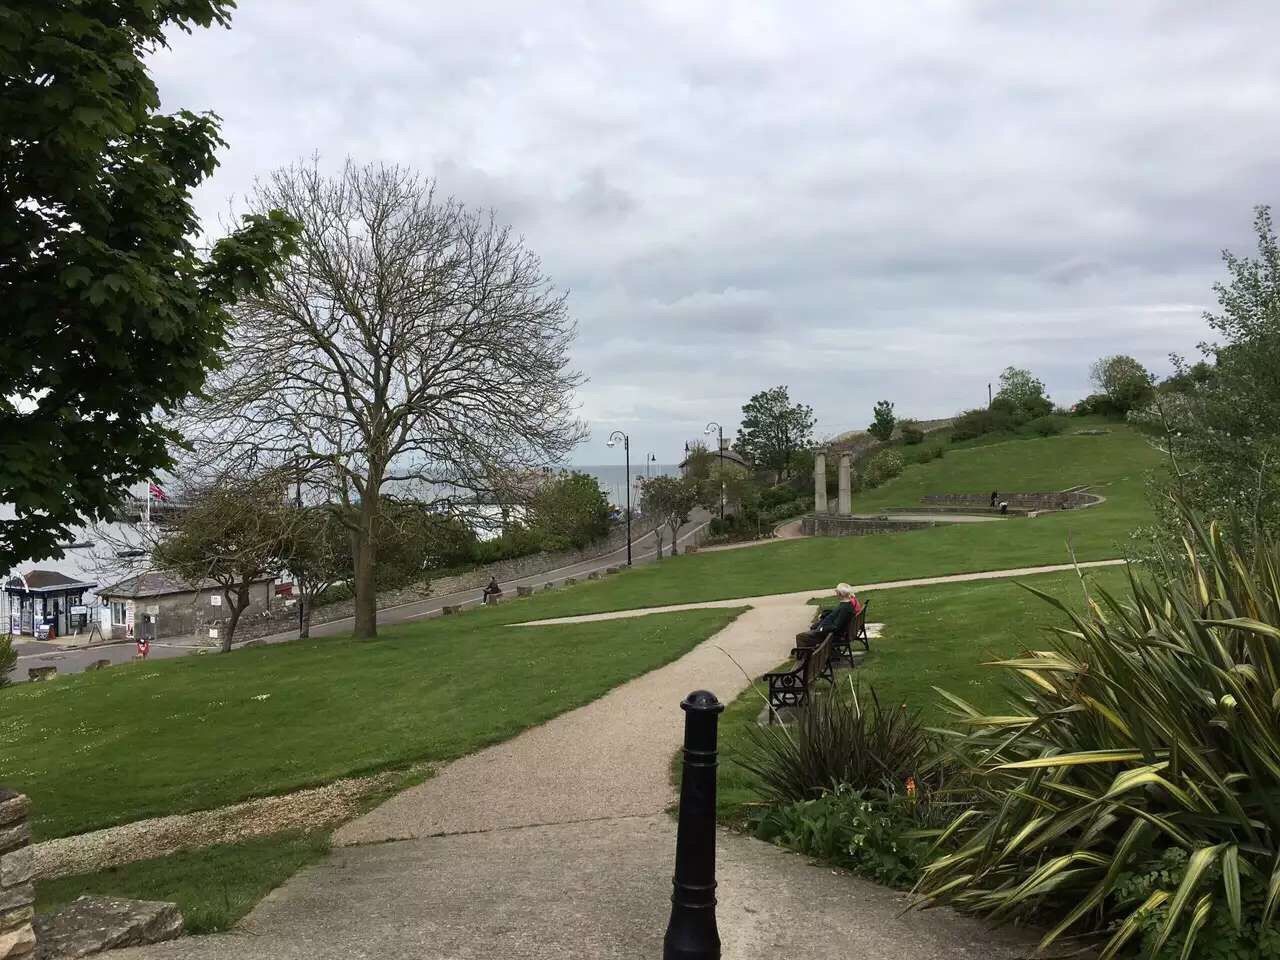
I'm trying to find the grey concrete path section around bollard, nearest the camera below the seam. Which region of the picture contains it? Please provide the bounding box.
[113,814,1034,960]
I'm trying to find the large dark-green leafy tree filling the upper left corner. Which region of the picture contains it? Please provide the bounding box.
[0,0,293,568]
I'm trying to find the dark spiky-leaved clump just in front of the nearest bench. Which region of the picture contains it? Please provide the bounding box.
[735,680,941,805]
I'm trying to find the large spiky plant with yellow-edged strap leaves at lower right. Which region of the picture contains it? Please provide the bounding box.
[916,511,1280,960]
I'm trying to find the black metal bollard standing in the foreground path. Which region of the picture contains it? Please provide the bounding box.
[662,690,724,960]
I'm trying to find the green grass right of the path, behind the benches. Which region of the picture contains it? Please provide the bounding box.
[718,567,1126,823]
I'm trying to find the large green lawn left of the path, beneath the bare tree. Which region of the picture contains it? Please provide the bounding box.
[0,602,736,840]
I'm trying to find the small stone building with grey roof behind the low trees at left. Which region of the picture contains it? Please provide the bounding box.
[97,572,275,640]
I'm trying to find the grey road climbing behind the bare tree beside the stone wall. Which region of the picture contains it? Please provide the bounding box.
[10,511,710,682]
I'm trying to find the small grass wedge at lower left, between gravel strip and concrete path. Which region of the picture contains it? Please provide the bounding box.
[36,832,329,933]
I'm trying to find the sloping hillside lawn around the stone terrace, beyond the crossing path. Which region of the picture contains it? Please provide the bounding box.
[504,424,1160,618]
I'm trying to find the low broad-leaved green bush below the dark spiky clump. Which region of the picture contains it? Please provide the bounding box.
[756,787,932,890]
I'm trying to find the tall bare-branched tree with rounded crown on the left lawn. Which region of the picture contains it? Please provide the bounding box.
[183,163,585,637]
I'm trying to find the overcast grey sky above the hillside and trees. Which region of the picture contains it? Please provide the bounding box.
[154,0,1280,463]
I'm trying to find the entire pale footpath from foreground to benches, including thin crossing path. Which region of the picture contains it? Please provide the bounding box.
[118,564,1121,960]
